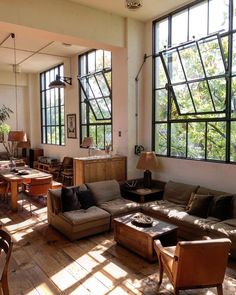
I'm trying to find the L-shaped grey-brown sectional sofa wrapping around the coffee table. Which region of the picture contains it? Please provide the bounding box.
[47,180,236,258]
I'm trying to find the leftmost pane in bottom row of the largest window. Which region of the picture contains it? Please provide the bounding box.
[155,124,167,155]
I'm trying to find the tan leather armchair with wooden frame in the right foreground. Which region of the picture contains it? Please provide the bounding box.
[154,238,231,295]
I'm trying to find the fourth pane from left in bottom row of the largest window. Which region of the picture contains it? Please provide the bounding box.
[207,122,226,161]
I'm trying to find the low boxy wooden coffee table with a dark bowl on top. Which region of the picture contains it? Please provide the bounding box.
[114,214,178,262]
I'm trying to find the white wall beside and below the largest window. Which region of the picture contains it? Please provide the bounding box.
[142,22,236,193]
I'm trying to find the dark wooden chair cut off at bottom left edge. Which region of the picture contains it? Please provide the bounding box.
[0,229,13,295]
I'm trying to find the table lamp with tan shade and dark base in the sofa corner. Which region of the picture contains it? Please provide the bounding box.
[136,152,158,188]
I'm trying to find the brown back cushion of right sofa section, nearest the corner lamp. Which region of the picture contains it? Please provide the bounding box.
[163,181,198,206]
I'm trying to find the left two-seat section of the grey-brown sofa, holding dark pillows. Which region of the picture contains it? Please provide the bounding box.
[47,180,141,241]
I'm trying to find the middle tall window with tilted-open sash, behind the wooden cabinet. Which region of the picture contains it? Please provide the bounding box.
[79,50,112,149]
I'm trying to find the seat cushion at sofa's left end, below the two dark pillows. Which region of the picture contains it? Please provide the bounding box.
[61,206,110,226]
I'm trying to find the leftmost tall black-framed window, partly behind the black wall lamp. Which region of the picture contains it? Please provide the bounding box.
[40,65,65,145]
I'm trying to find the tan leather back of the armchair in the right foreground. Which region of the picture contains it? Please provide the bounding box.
[172,238,231,287]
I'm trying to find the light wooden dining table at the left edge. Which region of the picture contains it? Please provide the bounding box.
[0,168,48,211]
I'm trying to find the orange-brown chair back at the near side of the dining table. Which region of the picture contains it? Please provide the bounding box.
[27,175,52,197]
